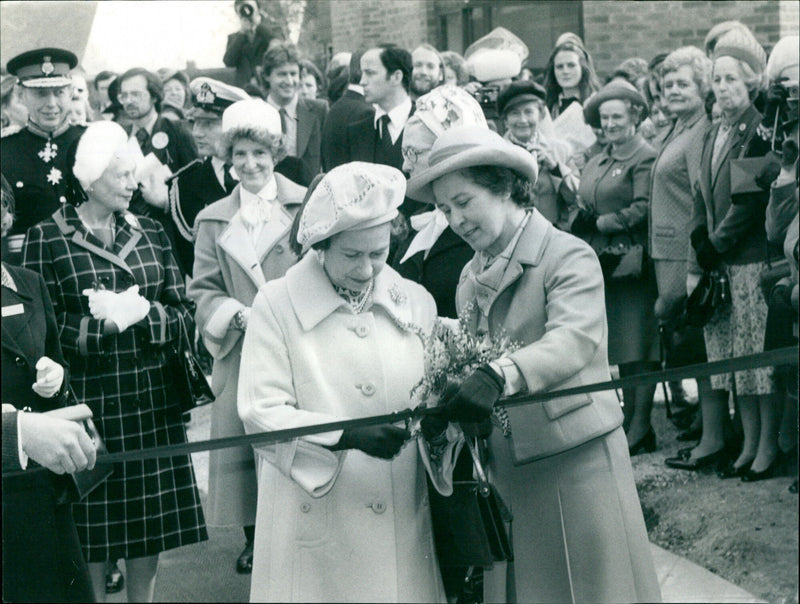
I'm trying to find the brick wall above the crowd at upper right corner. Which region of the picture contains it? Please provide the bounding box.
[583,0,798,76]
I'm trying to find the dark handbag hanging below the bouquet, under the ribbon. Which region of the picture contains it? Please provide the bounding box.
[430,438,514,567]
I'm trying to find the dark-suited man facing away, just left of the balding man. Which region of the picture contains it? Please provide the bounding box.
[322,50,375,172]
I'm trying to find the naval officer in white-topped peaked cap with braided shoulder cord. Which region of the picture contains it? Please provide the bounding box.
[167,77,250,276]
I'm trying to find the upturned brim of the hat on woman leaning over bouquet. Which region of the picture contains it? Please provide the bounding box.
[406,145,538,204]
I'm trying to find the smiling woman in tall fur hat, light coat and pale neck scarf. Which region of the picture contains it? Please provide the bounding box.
[188,100,305,573]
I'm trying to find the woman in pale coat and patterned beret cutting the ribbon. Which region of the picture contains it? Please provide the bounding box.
[238,162,444,602]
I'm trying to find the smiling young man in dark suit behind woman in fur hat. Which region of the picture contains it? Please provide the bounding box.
[262,42,328,186]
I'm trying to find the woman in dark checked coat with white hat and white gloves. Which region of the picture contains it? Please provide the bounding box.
[23,121,208,602]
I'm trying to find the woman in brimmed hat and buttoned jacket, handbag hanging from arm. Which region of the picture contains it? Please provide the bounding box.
[570,80,658,454]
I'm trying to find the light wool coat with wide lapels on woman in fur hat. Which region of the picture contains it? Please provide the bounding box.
[187,174,305,526]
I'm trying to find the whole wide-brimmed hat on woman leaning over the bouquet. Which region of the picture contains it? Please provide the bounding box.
[406,126,539,203]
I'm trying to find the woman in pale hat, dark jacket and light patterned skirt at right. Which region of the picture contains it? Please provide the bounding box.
[667,27,781,481]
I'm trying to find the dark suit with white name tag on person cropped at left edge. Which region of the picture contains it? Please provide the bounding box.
[2,265,94,602]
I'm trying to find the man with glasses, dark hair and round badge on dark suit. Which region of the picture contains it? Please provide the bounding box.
[117,67,197,235]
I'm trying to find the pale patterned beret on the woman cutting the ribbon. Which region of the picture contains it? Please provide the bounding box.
[297,162,406,252]
